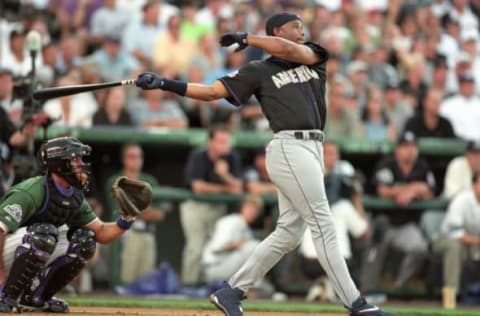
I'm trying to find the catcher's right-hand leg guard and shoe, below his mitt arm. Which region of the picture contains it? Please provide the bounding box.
[20,228,97,313]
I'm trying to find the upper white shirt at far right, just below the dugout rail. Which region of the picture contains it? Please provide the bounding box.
[443,156,472,199]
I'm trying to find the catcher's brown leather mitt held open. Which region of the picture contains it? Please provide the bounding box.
[112,176,152,218]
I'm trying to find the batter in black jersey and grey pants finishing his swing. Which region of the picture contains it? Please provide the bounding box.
[137,13,393,316]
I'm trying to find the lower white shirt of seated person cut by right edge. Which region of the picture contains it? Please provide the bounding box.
[441,189,480,238]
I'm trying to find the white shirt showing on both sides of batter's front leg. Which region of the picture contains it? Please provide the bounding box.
[300,199,368,259]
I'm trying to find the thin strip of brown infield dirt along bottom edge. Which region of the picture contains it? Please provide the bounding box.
[22,306,342,316]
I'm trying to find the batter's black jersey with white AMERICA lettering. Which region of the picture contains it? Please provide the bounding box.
[219,42,328,132]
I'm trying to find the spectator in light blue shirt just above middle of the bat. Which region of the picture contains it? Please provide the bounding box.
[88,35,140,81]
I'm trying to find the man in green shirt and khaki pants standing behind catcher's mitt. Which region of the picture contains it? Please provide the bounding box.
[105,143,165,282]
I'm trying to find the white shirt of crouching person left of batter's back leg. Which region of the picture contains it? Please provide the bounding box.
[202,214,254,265]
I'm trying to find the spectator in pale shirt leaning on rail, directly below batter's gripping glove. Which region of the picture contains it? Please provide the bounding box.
[129,89,188,128]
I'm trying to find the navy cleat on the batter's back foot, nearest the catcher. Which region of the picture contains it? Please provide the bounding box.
[210,282,247,316]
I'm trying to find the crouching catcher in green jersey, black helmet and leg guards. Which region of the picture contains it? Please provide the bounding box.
[0,137,152,313]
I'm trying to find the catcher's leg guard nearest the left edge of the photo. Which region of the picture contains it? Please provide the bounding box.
[3,223,58,299]
